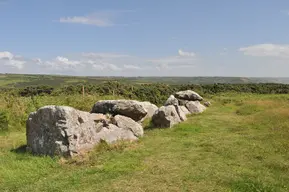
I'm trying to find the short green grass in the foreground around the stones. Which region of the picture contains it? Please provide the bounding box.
[0,94,289,192]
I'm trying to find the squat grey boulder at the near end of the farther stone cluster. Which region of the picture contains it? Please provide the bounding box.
[152,105,181,127]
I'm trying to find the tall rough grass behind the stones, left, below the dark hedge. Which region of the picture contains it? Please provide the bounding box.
[0,94,121,132]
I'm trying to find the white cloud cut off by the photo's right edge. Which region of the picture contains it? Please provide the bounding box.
[239,44,289,58]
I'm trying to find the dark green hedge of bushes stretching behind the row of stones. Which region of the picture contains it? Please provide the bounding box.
[13,80,289,105]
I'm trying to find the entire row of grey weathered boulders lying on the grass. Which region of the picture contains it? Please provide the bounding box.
[26,90,205,156]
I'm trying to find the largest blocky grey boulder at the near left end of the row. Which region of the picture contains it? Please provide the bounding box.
[26,106,101,156]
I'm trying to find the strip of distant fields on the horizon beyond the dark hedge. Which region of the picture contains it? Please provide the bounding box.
[0,74,289,88]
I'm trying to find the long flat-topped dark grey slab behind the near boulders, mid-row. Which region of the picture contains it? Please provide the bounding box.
[91,100,147,121]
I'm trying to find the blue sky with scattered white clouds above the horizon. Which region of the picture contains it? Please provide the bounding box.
[0,0,289,77]
